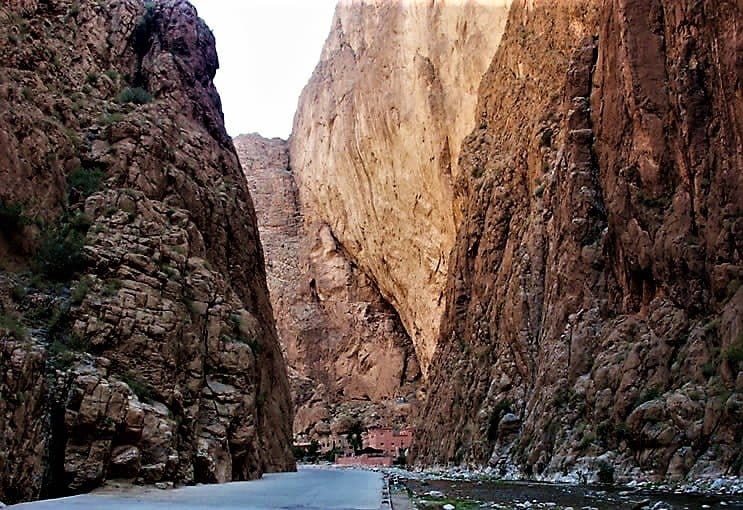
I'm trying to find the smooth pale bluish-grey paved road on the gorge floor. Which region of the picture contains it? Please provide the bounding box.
[9,468,382,510]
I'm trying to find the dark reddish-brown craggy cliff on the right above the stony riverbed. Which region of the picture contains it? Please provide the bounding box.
[417,0,743,479]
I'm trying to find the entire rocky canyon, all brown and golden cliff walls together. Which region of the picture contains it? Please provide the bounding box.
[0,0,743,502]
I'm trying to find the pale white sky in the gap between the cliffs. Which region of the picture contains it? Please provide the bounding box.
[191,0,337,138]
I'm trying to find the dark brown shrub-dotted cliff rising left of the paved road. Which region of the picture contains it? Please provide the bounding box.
[0,0,294,502]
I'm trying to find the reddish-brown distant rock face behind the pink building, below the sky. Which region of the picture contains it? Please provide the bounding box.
[235,135,420,439]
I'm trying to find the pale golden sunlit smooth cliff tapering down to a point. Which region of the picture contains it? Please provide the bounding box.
[290,0,511,374]
